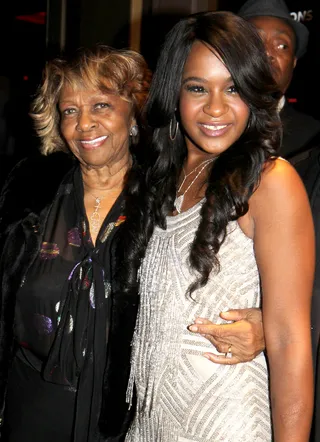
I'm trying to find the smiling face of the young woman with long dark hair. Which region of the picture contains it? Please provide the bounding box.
[179,42,250,161]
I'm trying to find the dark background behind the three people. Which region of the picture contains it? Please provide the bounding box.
[0,0,320,184]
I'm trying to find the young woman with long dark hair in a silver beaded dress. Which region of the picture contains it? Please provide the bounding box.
[123,12,314,442]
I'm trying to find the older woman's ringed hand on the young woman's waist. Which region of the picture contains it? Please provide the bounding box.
[189,308,265,365]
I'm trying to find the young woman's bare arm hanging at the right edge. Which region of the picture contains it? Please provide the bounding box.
[249,160,314,442]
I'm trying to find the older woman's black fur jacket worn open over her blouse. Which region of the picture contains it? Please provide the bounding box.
[0,153,138,442]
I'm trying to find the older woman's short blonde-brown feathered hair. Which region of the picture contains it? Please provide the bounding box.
[30,45,151,155]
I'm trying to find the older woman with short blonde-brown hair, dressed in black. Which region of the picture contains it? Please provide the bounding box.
[0,46,149,442]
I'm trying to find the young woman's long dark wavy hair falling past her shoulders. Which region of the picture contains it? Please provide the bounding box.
[120,12,281,293]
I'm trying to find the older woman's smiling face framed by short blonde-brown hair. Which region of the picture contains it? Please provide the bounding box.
[59,86,135,168]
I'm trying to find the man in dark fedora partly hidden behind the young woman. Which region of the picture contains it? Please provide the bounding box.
[238,0,320,164]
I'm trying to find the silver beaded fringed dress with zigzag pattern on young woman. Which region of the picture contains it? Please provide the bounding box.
[126,203,272,442]
